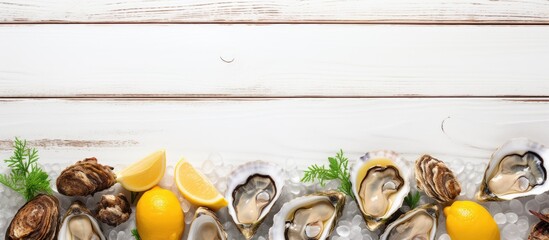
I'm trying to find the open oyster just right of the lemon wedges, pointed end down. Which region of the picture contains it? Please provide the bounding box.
[225,161,284,239]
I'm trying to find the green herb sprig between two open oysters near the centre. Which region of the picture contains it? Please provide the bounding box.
[301,150,355,199]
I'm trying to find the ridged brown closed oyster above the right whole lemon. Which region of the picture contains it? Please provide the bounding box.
[415,155,461,203]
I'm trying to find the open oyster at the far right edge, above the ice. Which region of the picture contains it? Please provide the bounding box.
[477,138,549,201]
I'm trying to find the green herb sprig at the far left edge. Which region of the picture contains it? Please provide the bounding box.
[0,138,52,201]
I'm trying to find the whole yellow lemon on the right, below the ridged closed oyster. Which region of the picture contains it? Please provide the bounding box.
[444,201,500,240]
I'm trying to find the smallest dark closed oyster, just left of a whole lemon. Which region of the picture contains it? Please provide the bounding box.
[96,193,132,227]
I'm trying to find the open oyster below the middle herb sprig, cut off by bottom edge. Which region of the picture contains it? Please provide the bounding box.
[269,191,345,240]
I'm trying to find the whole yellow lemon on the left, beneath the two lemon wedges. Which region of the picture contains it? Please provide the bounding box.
[135,186,185,240]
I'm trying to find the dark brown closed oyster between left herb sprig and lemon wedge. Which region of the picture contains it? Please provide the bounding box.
[56,158,116,196]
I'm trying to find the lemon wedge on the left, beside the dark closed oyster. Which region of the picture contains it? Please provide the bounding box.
[116,150,166,192]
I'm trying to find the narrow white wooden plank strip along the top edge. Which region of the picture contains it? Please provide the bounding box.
[0,0,549,24]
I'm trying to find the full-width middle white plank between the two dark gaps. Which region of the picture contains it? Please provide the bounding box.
[0,24,549,97]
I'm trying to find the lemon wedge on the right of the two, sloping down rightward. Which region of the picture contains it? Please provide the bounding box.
[175,158,227,211]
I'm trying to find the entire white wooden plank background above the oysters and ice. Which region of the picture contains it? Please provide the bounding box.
[0,0,549,169]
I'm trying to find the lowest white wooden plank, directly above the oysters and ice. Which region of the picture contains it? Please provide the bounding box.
[0,98,549,167]
